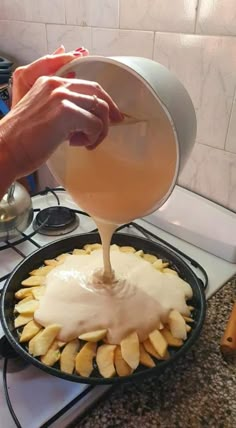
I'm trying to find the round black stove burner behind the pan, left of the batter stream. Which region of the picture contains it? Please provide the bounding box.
[33,205,79,236]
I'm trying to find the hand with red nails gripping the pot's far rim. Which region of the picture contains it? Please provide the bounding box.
[12,46,89,107]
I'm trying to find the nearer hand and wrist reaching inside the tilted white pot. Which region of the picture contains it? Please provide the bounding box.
[0,73,123,181]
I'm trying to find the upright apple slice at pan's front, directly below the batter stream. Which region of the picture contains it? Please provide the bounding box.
[96,345,116,378]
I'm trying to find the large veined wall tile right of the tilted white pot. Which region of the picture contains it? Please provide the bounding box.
[154,33,236,149]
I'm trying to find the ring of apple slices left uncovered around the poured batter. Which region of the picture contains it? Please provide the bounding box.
[14,244,194,378]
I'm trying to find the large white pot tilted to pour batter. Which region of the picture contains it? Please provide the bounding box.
[48,56,197,224]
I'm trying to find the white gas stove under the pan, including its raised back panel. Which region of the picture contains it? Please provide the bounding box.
[0,186,236,428]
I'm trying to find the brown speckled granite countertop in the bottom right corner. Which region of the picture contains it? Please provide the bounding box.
[73,278,236,428]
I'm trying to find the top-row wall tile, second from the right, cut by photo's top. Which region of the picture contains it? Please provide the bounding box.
[120,0,197,33]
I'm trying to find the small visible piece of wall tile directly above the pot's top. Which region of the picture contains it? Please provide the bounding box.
[92,28,154,58]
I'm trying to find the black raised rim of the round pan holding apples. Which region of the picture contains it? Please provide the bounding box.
[0,232,206,385]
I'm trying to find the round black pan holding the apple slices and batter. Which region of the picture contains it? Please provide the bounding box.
[1,233,206,385]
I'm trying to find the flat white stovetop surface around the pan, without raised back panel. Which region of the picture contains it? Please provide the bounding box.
[0,188,236,428]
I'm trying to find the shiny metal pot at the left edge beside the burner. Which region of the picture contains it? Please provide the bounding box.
[0,182,33,241]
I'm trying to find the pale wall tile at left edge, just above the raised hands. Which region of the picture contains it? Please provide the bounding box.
[0,21,47,65]
